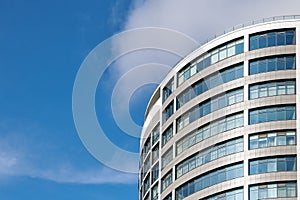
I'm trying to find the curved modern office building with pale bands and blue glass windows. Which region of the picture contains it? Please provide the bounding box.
[139,16,300,200]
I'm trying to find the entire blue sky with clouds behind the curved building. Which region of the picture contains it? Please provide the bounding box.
[0,0,300,200]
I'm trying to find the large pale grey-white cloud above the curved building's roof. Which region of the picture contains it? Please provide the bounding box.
[108,0,300,136]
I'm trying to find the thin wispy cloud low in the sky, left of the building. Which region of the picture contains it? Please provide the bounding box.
[0,120,137,184]
